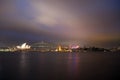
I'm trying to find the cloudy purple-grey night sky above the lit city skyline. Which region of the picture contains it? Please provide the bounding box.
[0,0,120,47]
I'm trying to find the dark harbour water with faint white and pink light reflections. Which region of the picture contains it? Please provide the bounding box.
[0,53,120,80]
